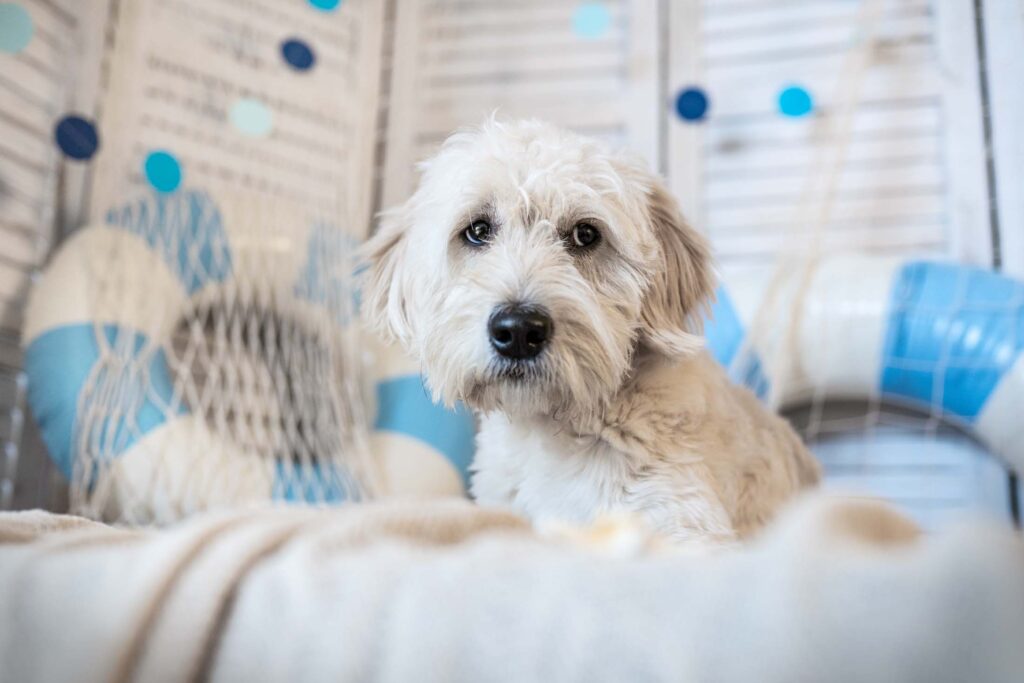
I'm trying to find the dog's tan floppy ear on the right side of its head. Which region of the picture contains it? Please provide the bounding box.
[641,178,715,358]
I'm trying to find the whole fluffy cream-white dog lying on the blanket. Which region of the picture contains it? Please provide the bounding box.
[366,121,818,542]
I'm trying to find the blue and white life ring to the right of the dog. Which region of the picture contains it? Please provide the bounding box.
[705,256,1024,472]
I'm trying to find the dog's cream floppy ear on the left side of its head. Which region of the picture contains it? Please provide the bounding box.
[359,209,412,347]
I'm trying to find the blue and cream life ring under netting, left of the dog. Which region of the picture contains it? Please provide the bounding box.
[24,190,474,520]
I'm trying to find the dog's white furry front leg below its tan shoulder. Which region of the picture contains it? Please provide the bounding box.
[627,464,736,546]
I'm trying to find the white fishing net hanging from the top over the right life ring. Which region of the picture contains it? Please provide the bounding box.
[712,0,1024,526]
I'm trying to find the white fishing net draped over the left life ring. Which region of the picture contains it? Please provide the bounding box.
[56,190,375,522]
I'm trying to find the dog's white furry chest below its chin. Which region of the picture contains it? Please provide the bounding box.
[472,416,635,522]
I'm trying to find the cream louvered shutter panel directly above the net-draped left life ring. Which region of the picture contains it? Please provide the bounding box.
[92,0,383,234]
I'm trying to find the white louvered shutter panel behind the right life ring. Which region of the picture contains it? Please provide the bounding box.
[669,0,991,267]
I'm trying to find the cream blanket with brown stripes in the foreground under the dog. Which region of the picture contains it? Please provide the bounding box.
[0,495,1024,683]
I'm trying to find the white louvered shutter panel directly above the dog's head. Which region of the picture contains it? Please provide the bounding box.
[383,0,659,206]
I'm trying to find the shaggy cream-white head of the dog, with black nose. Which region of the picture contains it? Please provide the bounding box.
[365,121,714,420]
